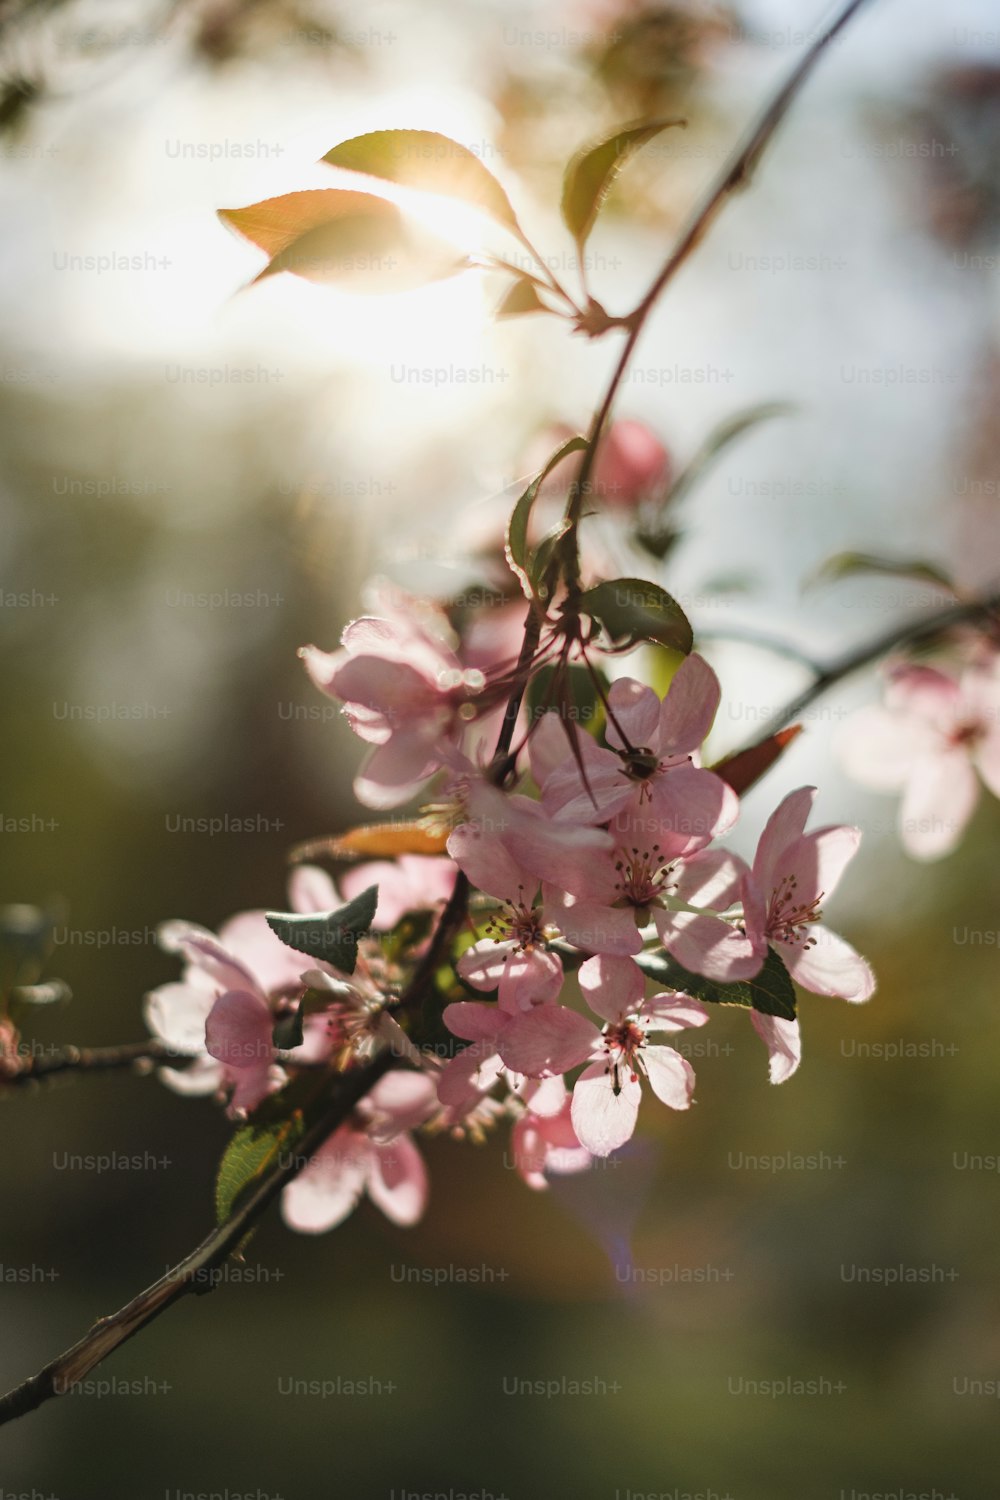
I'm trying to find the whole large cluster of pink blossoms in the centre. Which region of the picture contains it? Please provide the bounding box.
[147,432,874,1232]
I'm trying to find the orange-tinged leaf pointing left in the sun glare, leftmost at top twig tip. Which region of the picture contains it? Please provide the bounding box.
[219,189,463,293]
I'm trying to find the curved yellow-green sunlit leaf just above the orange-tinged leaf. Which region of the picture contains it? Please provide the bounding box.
[322,131,519,233]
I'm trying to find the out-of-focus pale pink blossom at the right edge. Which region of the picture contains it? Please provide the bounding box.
[841,654,1000,860]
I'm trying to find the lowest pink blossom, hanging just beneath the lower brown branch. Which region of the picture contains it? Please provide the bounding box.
[282,1071,435,1235]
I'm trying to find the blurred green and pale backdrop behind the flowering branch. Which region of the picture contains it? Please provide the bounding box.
[0,0,1000,1500]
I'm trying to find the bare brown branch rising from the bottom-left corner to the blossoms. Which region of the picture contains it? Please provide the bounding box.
[0,1052,399,1427]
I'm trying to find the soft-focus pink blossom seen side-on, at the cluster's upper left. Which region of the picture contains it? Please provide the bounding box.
[300,600,486,809]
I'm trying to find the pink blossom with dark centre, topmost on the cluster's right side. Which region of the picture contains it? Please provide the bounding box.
[532,654,739,854]
